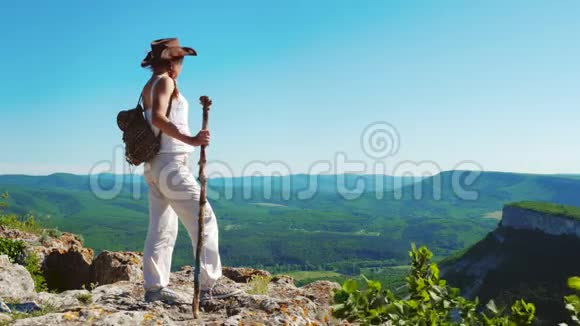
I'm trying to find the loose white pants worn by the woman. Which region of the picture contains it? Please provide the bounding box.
[143,153,222,290]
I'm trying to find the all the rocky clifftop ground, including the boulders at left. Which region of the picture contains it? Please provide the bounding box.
[0,225,339,325]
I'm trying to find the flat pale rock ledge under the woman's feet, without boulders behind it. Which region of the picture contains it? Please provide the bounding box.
[2,266,340,326]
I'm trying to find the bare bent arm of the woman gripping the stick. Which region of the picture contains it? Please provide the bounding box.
[151,78,209,146]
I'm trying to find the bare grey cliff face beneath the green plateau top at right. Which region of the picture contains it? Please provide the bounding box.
[500,206,580,238]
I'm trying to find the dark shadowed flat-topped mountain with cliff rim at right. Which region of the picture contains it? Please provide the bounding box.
[440,202,580,325]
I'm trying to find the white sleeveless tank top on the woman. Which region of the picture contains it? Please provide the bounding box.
[143,77,193,153]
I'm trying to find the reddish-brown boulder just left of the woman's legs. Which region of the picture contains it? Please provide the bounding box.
[90,251,143,285]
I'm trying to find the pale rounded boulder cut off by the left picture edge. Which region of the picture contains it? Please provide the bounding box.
[0,255,36,301]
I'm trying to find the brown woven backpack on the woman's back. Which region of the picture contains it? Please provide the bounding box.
[117,94,172,165]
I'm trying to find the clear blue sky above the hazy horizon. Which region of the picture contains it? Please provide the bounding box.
[0,0,580,175]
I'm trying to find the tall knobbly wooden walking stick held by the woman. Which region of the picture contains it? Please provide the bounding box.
[192,96,212,319]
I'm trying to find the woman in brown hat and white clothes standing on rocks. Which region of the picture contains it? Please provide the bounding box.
[141,38,240,302]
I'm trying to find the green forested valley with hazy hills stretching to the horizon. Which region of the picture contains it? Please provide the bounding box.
[0,171,580,275]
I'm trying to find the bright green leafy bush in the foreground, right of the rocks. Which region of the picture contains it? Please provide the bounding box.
[332,245,535,326]
